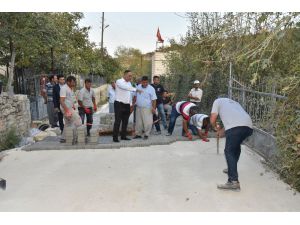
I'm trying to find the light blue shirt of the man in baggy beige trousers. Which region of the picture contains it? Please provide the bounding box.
[136,84,157,109]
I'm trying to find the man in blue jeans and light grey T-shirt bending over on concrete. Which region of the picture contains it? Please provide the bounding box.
[210,98,253,190]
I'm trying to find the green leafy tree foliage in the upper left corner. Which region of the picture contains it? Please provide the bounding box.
[0,12,119,81]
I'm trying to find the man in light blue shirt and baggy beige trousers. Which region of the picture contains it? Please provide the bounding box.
[134,76,157,140]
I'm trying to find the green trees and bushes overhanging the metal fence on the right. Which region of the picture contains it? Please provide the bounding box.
[163,13,300,188]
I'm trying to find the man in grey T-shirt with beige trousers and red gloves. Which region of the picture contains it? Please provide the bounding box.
[60,76,81,142]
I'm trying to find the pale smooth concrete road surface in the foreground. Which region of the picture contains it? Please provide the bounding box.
[0,139,300,211]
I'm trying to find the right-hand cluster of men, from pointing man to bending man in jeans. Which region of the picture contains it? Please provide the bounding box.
[113,70,253,190]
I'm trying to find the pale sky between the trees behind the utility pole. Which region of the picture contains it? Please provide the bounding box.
[79,12,189,55]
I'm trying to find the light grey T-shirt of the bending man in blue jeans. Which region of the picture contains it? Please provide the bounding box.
[211,98,253,130]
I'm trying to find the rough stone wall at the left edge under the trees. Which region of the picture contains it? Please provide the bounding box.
[0,92,31,136]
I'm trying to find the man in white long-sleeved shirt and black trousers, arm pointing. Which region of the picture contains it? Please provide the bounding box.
[113,70,142,142]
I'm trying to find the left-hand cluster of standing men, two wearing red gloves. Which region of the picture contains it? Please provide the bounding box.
[43,75,97,143]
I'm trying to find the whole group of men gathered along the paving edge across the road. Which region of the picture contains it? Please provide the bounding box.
[45,70,253,190]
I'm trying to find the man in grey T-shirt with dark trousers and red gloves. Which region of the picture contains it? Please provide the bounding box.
[78,79,97,136]
